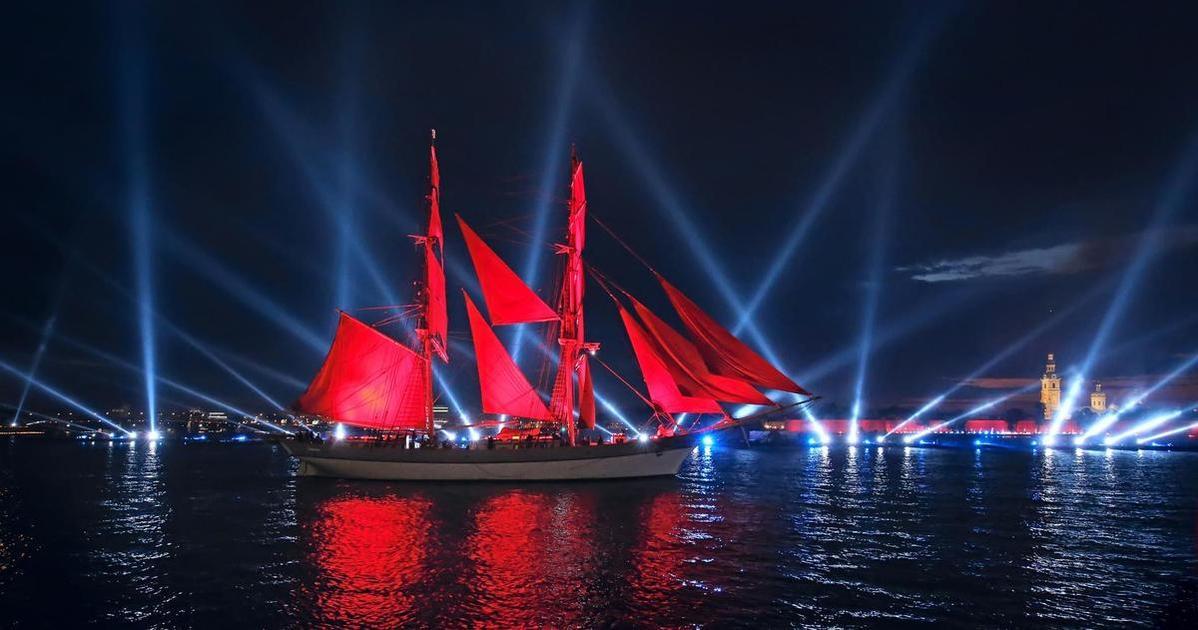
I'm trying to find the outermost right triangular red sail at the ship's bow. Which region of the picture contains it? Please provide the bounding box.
[658,275,810,395]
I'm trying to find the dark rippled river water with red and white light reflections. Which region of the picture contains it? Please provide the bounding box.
[0,440,1198,628]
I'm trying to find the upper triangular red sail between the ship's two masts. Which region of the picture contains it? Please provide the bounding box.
[458,216,557,326]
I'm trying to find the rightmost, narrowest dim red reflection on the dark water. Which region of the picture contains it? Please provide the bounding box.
[629,492,686,610]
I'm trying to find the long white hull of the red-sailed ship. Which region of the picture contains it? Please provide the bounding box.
[286,444,692,481]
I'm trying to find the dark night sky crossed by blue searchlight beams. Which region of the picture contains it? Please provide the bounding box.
[0,1,1198,418]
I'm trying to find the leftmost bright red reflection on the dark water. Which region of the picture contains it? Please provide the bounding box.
[314,497,431,625]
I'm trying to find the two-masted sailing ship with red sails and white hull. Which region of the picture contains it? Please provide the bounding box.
[283,132,812,480]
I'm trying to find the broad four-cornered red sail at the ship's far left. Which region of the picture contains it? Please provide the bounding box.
[297,313,429,429]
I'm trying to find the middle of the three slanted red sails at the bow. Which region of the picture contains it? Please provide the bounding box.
[629,296,774,405]
